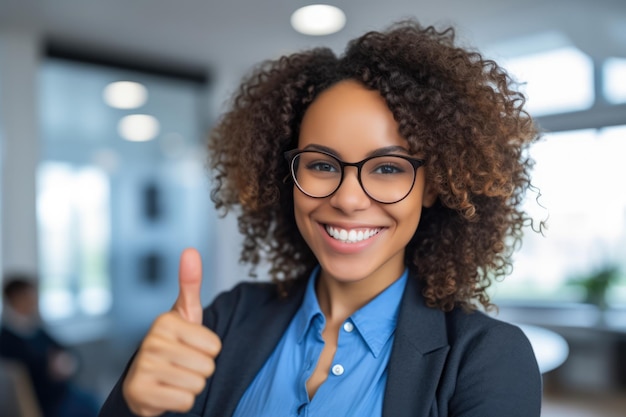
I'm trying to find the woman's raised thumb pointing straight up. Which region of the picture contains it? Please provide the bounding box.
[173,248,202,324]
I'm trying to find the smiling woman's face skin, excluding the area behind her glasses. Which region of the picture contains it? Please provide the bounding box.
[294,81,436,286]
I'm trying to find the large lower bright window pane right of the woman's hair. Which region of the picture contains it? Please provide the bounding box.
[495,126,626,305]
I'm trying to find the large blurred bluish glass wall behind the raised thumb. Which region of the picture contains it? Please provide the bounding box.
[37,58,213,328]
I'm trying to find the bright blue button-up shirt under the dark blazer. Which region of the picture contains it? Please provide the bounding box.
[234,268,408,417]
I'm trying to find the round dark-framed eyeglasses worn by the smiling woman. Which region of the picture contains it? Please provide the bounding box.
[285,149,426,204]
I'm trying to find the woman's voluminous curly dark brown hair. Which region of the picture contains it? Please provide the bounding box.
[209,20,538,311]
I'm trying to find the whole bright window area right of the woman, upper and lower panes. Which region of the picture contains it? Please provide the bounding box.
[482,36,626,306]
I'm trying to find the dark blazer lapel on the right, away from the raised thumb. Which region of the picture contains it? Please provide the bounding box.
[383,276,450,417]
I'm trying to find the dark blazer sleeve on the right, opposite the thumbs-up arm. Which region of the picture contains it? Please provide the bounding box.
[449,323,542,417]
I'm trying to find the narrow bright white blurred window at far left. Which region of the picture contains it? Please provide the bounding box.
[37,162,111,320]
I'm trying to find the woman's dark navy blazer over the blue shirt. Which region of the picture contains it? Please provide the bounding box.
[100,277,541,417]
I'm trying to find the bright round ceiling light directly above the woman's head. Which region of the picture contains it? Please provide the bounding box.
[291,4,346,36]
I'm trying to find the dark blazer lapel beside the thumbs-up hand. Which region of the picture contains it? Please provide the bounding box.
[202,280,306,417]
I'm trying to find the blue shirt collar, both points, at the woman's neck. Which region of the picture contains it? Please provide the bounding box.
[295,265,409,357]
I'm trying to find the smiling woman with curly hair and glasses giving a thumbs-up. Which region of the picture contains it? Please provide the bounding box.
[102,21,541,417]
